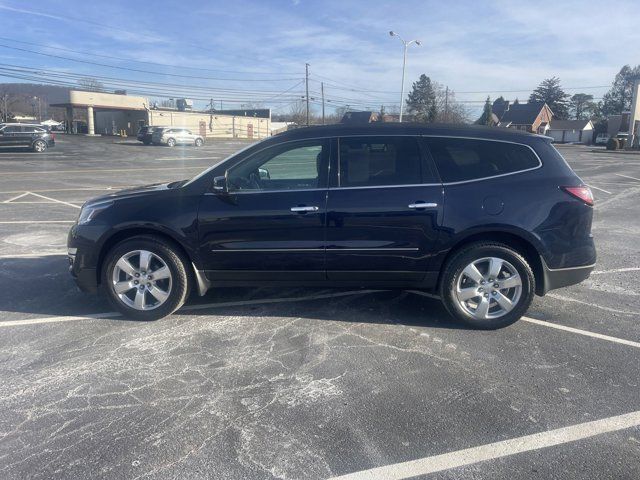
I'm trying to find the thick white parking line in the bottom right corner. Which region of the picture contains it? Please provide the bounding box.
[331,411,640,480]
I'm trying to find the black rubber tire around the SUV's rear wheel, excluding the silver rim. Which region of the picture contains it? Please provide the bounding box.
[440,242,536,330]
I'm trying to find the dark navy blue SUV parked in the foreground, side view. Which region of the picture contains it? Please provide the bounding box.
[68,124,596,329]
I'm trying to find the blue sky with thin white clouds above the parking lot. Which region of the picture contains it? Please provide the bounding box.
[0,0,640,115]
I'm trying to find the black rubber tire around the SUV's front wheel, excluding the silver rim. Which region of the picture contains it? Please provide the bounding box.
[101,235,190,321]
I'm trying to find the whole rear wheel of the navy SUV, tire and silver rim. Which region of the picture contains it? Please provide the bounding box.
[440,242,535,330]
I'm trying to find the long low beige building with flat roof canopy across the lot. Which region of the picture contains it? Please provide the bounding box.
[52,90,271,139]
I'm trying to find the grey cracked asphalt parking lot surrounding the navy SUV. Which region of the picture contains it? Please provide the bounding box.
[0,135,640,480]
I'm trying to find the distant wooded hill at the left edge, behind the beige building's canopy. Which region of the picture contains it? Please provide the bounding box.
[0,83,71,120]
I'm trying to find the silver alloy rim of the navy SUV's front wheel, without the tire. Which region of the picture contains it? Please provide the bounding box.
[111,250,171,310]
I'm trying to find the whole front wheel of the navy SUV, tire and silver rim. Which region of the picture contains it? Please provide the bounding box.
[102,236,189,320]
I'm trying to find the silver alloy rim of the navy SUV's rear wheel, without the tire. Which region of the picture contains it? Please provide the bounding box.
[453,257,522,320]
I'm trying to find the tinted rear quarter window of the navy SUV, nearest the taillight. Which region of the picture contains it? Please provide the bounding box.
[427,137,540,183]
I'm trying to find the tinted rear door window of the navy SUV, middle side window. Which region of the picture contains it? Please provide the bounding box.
[339,136,432,187]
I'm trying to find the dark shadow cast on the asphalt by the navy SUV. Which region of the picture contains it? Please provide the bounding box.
[0,255,468,329]
